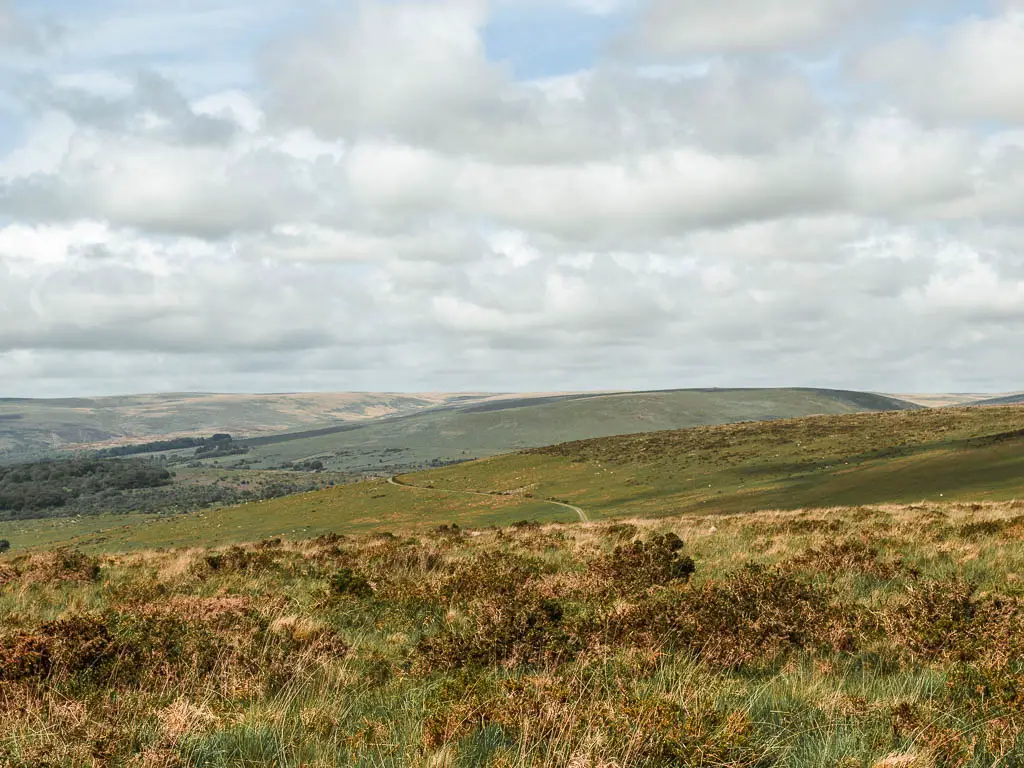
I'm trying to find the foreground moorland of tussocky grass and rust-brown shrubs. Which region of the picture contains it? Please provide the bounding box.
[0,503,1024,768]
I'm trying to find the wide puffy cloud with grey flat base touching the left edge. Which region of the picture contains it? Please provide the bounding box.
[0,73,336,239]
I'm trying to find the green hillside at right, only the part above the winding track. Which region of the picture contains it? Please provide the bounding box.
[411,407,1024,516]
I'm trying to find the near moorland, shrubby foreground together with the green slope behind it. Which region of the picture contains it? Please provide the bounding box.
[0,407,1024,768]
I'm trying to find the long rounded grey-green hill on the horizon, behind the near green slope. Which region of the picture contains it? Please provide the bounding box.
[237,389,909,471]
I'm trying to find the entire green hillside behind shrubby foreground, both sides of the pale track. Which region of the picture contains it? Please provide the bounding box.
[0,407,1024,551]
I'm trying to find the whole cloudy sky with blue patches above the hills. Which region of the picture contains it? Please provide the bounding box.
[0,0,1024,396]
